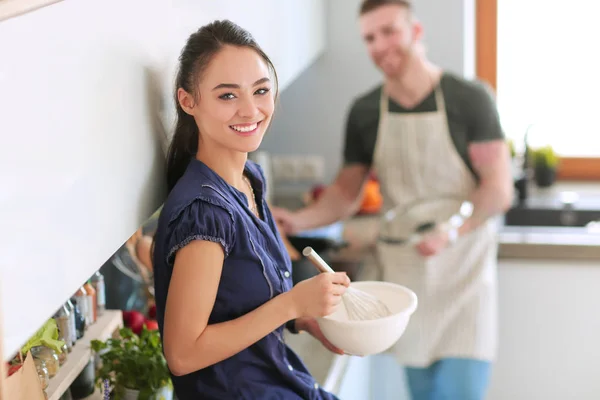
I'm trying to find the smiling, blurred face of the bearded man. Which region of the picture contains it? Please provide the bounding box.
[360,4,422,77]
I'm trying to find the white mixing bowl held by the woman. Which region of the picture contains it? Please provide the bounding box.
[317,281,417,356]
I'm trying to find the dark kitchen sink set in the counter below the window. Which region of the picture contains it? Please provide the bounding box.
[504,196,600,227]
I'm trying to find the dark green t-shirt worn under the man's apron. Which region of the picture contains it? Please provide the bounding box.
[344,72,504,175]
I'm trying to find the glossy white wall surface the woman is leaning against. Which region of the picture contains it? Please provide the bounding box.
[0,0,325,357]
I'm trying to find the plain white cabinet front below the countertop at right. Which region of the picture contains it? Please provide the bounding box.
[488,260,600,400]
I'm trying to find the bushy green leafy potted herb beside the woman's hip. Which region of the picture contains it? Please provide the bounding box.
[91,326,173,400]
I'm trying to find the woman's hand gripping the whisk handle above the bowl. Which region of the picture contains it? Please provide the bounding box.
[288,272,350,318]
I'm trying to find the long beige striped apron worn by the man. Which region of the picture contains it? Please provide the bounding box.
[374,84,497,367]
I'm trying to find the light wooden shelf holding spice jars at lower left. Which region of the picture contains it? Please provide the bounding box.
[46,310,123,400]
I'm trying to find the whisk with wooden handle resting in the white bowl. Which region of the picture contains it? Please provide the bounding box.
[302,247,392,321]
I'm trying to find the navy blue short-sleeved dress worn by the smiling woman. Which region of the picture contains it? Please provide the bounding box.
[153,159,336,400]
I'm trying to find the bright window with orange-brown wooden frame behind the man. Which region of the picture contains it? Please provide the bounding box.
[477,0,600,179]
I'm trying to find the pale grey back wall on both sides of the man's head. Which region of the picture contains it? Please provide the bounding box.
[263,0,475,185]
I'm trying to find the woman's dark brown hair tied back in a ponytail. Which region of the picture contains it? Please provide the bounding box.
[167,20,277,192]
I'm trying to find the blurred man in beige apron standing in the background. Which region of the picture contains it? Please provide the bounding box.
[274,0,513,400]
